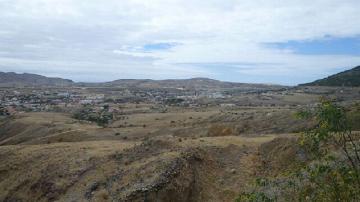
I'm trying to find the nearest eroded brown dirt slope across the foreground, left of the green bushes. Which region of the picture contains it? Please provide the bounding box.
[0,136,278,201]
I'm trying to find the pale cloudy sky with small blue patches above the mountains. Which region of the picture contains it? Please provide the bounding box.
[0,0,360,85]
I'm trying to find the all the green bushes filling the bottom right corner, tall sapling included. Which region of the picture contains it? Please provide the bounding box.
[236,100,360,202]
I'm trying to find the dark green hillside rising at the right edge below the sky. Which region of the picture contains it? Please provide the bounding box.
[301,66,360,87]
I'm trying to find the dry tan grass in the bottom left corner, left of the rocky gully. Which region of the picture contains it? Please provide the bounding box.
[0,141,134,201]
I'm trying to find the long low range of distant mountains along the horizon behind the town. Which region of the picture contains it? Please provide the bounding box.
[0,72,283,91]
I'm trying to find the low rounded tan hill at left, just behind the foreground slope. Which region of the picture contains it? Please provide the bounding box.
[0,113,121,145]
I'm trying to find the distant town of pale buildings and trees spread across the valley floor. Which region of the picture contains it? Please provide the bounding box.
[0,87,281,118]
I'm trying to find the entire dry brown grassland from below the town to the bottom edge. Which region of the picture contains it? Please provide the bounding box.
[0,86,359,201]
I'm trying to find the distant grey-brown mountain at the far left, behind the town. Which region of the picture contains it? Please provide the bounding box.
[0,72,74,87]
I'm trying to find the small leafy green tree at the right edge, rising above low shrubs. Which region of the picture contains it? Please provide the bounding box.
[299,99,360,180]
